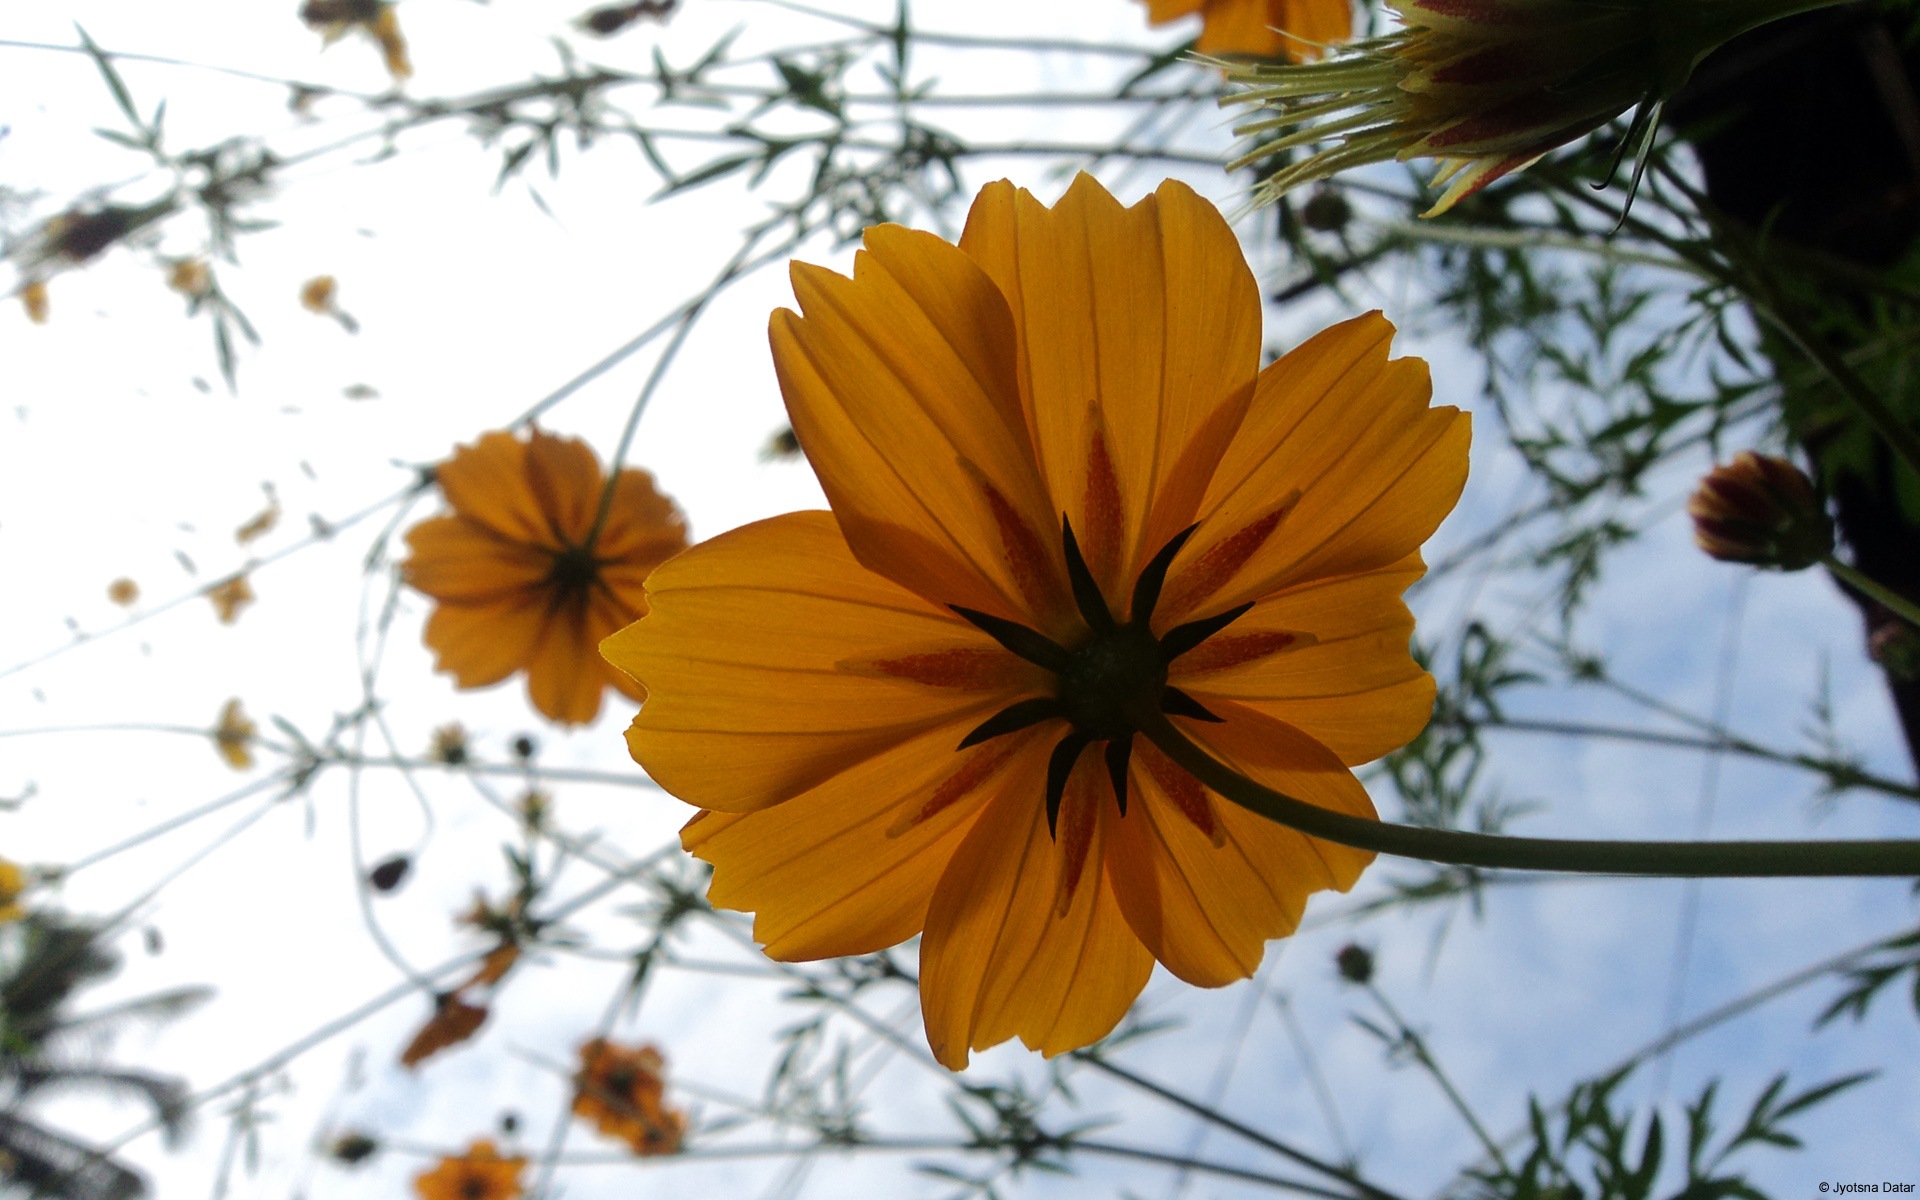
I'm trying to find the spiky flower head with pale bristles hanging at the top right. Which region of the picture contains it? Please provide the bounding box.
[1219,0,1830,217]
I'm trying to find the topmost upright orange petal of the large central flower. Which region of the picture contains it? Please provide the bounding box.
[956,175,1260,605]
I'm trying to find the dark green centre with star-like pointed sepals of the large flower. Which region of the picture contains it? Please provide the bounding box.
[948,518,1254,831]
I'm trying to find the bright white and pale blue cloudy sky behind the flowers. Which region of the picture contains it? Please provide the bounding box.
[0,0,1920,1200]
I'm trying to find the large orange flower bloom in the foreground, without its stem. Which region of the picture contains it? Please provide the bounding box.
[603,175,1469,1069]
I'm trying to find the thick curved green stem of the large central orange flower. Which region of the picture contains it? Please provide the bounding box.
[1135,708,1920,879]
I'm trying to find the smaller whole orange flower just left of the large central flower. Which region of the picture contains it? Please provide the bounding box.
[401,430,687,724]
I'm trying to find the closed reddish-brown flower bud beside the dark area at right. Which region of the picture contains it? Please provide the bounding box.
[1686,449,1834,570]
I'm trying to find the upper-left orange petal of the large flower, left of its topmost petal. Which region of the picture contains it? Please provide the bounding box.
[770,225,1058,620]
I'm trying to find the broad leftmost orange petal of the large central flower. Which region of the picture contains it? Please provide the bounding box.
[601,513,1041,812]
